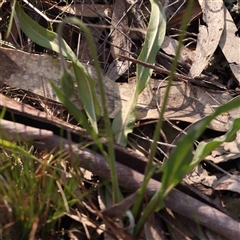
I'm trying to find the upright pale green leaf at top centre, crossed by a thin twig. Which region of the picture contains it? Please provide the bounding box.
[112,0,166,146]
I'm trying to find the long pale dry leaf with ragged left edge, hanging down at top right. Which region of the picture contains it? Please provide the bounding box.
[189,0,224,78]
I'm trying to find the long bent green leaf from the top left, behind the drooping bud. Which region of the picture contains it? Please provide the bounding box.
[16,3,101,132]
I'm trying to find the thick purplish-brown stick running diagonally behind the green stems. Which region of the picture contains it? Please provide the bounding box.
[0,120,240,239]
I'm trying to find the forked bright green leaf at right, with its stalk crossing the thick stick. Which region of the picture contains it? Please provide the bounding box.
[135,96,240,235]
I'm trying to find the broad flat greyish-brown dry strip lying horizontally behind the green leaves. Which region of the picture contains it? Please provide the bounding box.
[0,48,240,131]
